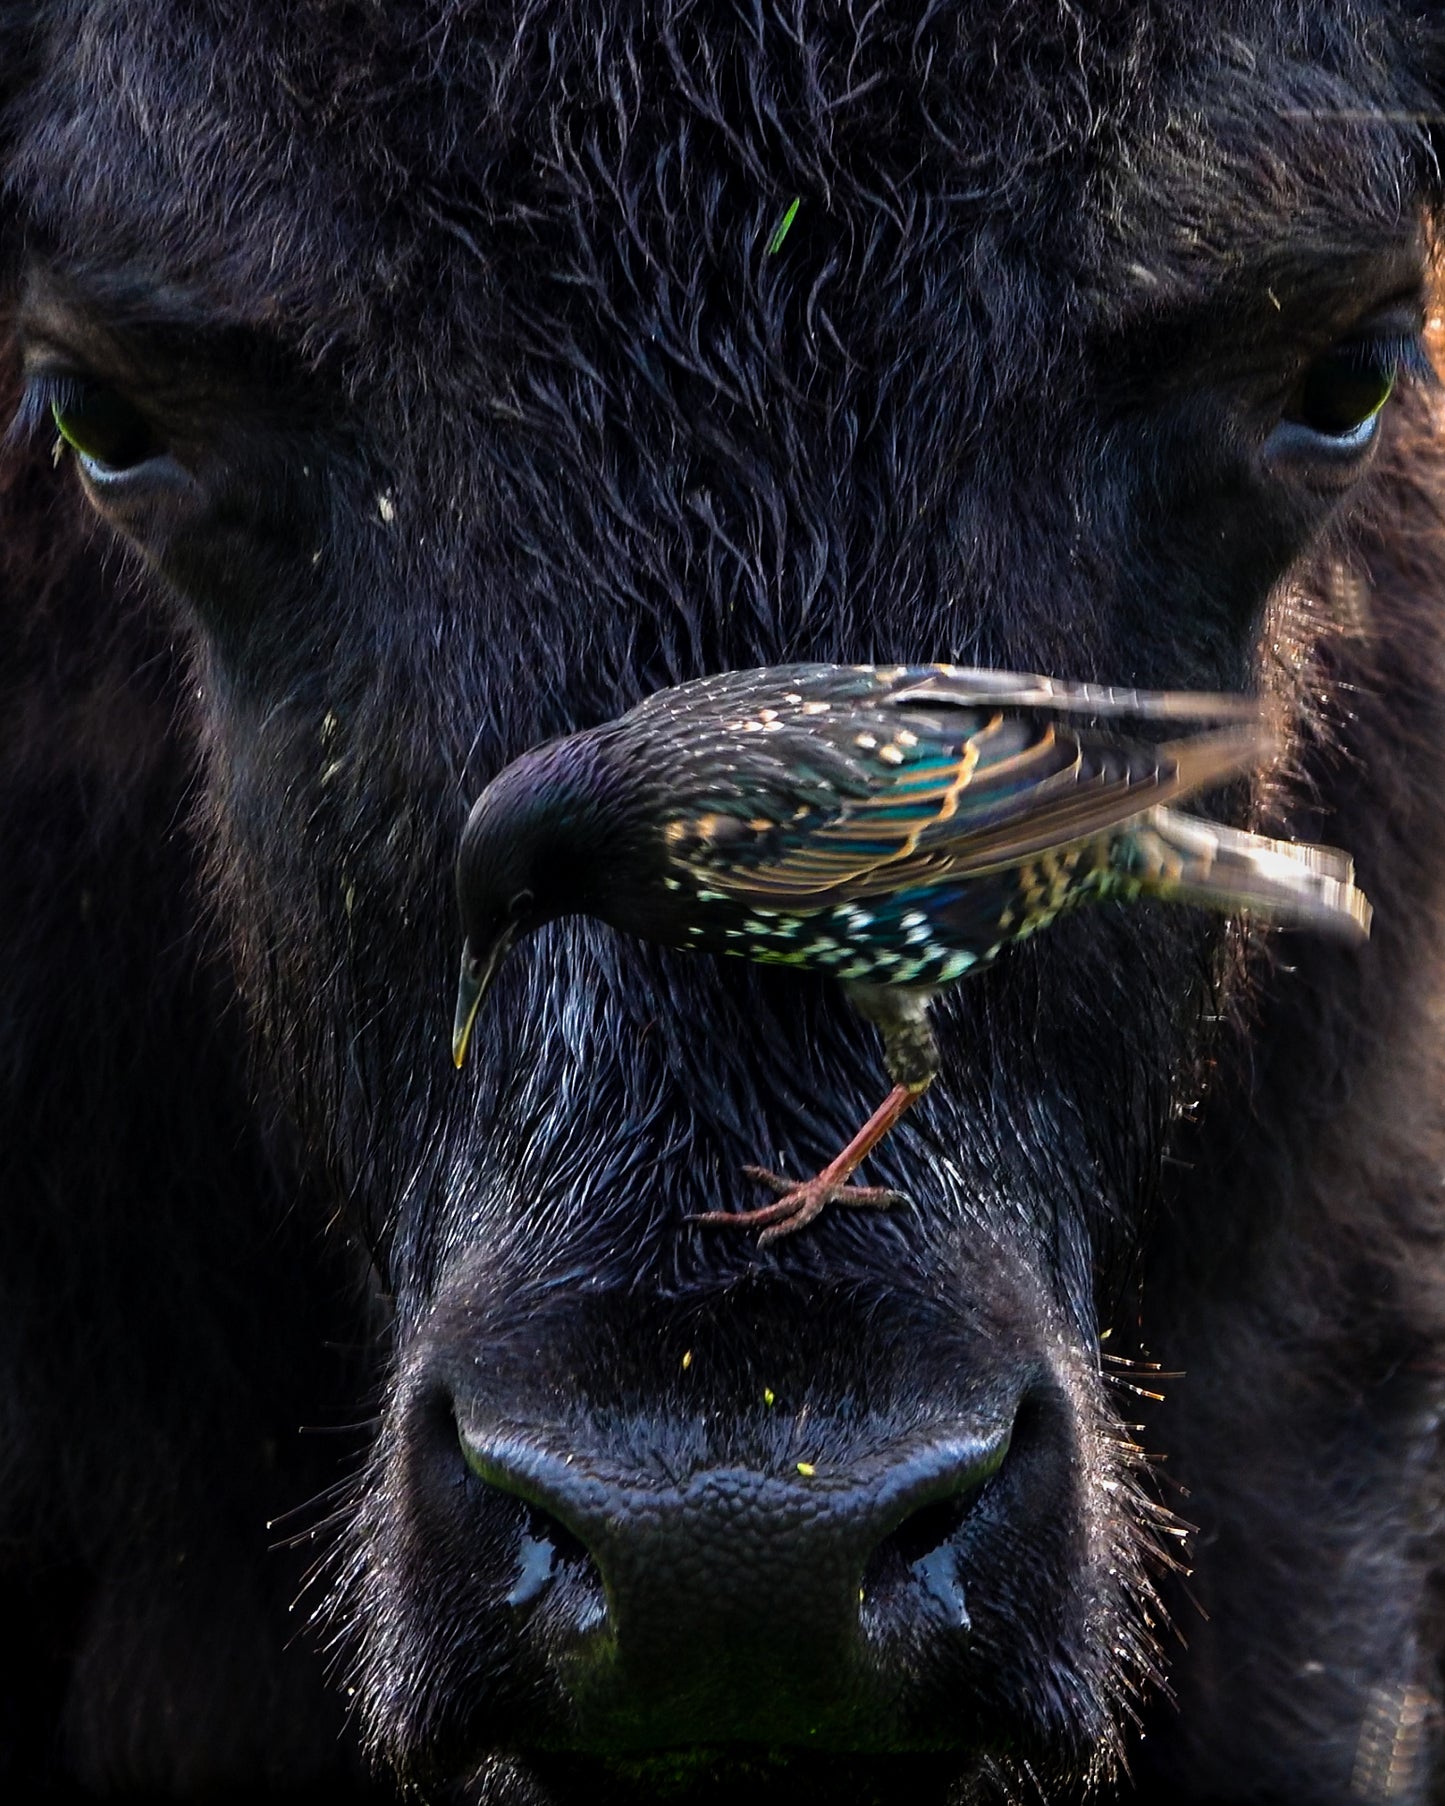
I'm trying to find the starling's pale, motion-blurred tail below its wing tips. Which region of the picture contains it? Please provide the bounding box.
[1114,807,1373,941]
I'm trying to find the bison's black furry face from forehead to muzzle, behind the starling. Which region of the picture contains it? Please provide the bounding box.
[11,0,1434,1799]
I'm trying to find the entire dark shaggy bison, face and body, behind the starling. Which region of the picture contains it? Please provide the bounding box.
[0,0,1445,1806]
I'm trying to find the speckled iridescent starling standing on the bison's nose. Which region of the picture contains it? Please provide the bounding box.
[452,665,1371,1243]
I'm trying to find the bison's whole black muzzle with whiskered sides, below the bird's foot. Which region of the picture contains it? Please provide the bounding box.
[375,1268,1123,1775]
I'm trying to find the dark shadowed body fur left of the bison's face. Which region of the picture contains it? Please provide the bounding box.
[0,344,390,1801]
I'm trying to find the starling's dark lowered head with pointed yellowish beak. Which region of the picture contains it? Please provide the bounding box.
[452,735,598,1066]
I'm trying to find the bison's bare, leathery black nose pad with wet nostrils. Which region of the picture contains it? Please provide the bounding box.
[461,1410,1015,1748]
